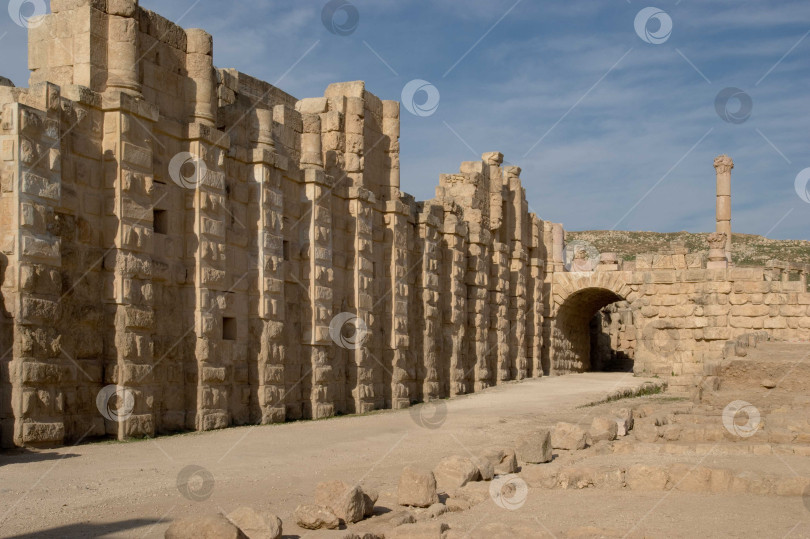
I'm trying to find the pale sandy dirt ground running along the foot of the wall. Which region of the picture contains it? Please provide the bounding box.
[0,373,810,538]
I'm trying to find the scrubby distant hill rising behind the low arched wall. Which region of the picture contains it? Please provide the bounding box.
[566,230,810,266]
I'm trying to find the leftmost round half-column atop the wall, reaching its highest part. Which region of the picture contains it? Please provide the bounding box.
[107,0,141,96]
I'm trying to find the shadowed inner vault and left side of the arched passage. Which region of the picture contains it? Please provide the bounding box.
[550,286,627,374]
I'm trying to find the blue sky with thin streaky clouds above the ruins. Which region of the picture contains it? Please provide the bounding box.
[0,0,810,239]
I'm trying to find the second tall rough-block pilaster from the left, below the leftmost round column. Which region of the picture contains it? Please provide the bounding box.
[104,93,159,440]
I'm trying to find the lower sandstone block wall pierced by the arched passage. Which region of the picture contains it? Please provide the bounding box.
[544,268,810,390]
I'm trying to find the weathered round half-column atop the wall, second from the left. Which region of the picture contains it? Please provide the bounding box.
[186,28,216,126]
